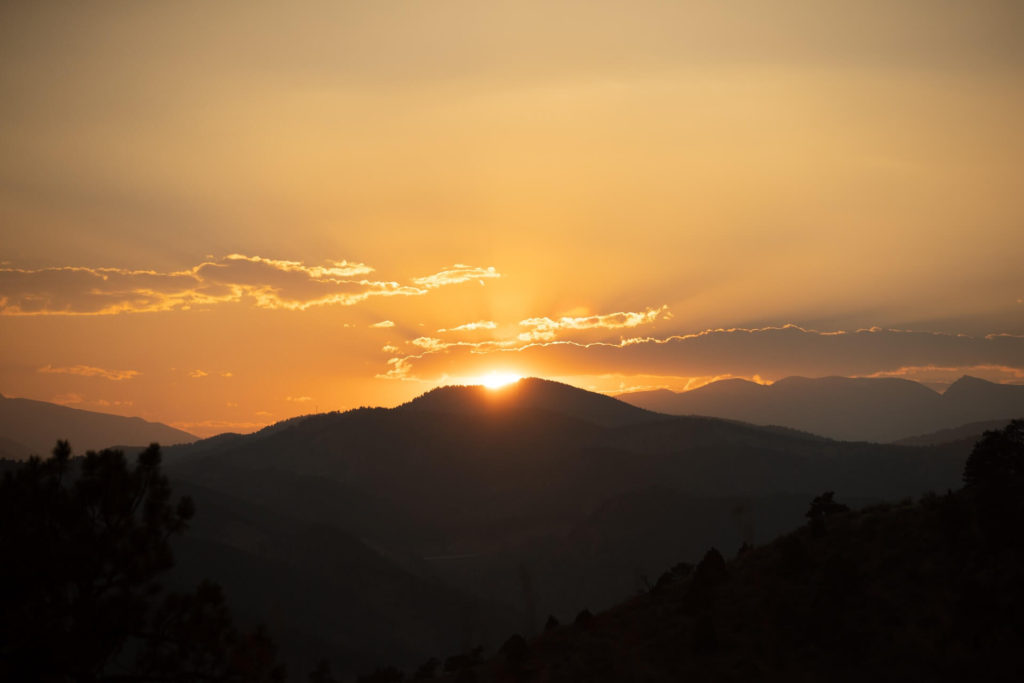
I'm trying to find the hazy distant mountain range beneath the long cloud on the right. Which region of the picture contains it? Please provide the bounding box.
[617,376,1024,442]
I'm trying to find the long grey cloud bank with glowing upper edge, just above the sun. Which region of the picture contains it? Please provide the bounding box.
[385,325,1024,380]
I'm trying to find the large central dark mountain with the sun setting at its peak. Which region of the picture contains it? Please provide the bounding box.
[166,379,969,661]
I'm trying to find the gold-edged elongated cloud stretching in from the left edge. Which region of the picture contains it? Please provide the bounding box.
[0,254,500,315]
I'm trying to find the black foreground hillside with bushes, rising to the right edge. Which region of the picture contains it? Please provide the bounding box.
[446,484,1024,683]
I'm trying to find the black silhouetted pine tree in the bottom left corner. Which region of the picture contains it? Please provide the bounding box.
[0,441,280,682]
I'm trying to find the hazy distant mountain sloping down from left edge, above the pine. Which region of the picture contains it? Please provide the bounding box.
[0,396,198,460]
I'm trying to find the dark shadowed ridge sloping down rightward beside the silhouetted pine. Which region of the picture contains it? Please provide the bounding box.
[170,482,519,680]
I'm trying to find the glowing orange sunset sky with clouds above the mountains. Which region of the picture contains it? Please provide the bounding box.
[0,0,1024,435]
